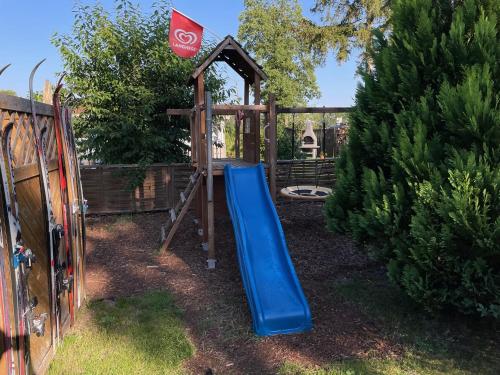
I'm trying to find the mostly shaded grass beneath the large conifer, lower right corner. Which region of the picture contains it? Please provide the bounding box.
[279,279,500,375]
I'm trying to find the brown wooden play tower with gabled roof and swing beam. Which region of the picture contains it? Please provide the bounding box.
[161,35,350,269]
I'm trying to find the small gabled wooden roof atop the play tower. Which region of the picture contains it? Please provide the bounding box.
[189,35,267,84]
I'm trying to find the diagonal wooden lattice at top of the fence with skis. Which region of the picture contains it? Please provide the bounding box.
[0,109,57,168]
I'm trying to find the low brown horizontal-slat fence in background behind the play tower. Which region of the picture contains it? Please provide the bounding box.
[80,159,335,214]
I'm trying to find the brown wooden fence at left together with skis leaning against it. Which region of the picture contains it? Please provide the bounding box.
[0,64,86,374]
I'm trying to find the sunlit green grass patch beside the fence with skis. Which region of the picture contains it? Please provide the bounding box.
[49,291,194,375]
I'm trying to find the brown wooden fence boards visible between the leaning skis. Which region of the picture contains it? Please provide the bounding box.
[0,94,84,373]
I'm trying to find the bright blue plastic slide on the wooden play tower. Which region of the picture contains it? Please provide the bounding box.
[224,164,312,336]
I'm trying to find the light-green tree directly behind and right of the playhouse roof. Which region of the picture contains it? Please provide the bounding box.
[238,0,320,105]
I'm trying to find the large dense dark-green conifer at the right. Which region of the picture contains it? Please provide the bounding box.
[326,0,500,318]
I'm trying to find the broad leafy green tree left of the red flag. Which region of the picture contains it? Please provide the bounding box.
[53,0,227,165]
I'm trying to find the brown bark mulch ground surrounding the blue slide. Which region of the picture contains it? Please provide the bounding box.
[87,202,401,374]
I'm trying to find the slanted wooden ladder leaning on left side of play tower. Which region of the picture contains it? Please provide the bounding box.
[160,171,203,252]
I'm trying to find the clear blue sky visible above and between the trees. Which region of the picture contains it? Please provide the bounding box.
[0,0,357,106]
